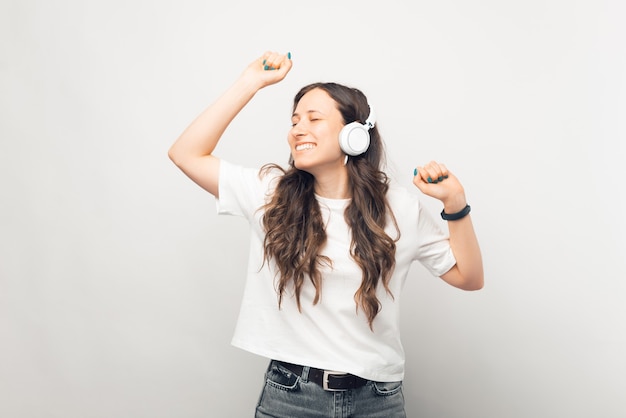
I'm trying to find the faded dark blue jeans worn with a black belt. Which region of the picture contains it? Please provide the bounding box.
[255,361,406,418]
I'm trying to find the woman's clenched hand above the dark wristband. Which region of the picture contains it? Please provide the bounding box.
[413,161,467,213]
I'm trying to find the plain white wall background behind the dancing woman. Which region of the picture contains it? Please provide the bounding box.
[0,0,626,418]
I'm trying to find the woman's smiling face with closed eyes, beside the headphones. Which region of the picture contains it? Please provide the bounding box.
[288,88,345,176]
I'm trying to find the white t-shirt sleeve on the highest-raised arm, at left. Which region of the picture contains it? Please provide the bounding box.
[216,160,268,219]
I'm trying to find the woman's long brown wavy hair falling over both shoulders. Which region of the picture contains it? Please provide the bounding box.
[263,83,400,329]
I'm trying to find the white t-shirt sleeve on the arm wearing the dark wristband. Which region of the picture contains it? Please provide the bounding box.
[417,205,456,277]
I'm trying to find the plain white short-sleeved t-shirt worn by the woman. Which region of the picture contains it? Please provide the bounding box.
[217,160,456,382]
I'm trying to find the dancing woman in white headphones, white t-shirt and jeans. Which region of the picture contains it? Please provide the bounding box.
[169,52,483,418]
